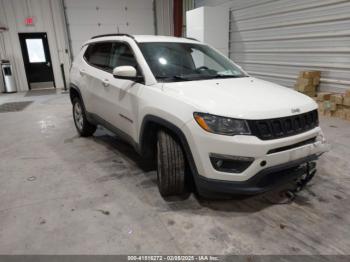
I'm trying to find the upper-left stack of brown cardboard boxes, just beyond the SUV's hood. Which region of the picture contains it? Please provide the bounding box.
[295,71,321,97]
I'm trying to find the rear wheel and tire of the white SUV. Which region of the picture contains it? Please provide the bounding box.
[73,97,97,137]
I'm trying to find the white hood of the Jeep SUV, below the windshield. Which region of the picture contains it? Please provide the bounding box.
[163,77,317,120]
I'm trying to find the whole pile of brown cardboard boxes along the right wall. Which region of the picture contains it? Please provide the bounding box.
[295,71,350,121]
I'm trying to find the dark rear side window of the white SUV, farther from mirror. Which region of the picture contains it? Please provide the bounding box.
[84,42,112,71]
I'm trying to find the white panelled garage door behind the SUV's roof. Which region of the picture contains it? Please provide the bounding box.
[64,0,154,56]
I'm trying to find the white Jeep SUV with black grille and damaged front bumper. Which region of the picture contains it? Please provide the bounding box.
[70,34,328,196]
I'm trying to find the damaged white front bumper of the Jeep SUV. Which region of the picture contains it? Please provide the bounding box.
[183,120,329,189]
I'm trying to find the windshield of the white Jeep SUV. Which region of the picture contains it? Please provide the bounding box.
[139,42,247,82]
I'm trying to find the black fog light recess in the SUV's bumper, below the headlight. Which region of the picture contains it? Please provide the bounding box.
[209,153,254,173]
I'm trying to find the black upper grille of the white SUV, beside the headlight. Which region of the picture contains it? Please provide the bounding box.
[248,110,318,140]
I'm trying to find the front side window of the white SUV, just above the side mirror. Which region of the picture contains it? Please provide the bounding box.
[109,43,139,74]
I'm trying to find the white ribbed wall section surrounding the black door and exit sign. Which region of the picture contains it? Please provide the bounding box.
[0,0,70,91]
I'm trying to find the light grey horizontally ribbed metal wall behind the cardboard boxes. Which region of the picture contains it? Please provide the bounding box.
[229,0,350,91]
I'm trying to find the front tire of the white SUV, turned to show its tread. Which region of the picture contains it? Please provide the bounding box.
[157,131,188,197]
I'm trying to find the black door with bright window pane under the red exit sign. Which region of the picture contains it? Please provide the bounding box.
[19,33,55,89]
